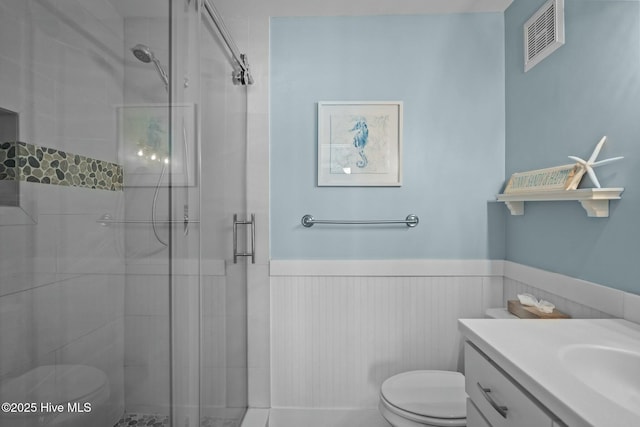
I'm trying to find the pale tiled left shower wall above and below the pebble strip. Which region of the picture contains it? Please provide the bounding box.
[0,0,124,426]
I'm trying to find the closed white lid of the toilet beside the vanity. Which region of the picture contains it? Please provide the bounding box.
[380,371,467,418]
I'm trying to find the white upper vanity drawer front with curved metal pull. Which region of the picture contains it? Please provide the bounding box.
[464,342,553,427]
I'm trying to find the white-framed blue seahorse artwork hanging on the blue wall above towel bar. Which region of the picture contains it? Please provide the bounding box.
[318,101,402,186]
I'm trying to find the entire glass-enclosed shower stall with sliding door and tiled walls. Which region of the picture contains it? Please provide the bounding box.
[0,0,254,427]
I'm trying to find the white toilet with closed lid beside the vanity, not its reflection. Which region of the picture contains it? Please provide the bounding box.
[378,308,516,427]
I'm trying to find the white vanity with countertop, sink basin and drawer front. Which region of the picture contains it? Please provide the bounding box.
[458,319,640,427]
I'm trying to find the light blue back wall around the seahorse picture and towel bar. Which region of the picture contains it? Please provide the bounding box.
[270,13,505,259]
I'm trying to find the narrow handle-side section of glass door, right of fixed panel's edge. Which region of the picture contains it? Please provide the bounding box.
[199,1,251,427]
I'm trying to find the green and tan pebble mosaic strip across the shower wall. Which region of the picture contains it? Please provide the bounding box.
[0,142,124,191]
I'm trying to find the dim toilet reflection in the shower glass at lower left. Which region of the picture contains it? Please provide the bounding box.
[0,365,110,427]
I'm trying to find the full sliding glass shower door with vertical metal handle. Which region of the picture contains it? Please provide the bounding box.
[171,0,249,427]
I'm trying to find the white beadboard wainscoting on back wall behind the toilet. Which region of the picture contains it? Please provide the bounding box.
[271,275,502,408]
